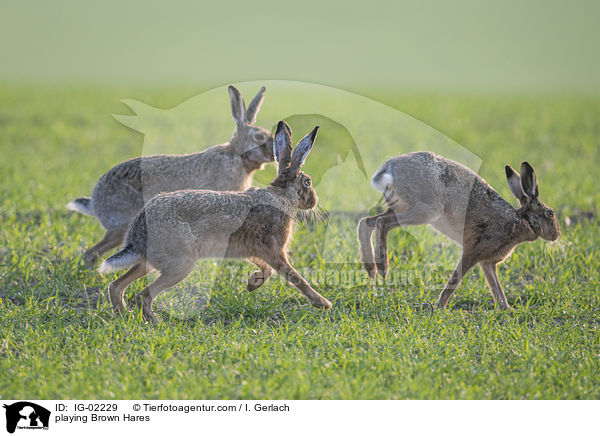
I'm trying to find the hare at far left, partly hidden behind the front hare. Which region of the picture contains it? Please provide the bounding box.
[67,86,273,268]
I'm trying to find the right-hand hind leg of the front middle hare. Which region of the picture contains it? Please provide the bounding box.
[135,259,196,324]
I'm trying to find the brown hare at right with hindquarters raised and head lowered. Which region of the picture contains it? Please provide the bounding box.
[357,152,560,309]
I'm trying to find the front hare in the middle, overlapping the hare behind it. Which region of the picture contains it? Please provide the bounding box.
[99,121,331,322]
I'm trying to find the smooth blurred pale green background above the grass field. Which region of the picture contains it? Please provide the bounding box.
[0,0,600,93]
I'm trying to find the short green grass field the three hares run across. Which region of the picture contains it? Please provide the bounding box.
[0,85,600,399]
